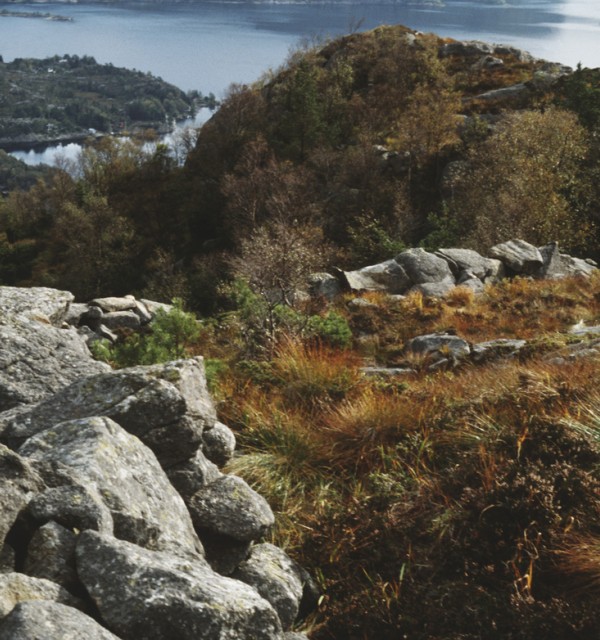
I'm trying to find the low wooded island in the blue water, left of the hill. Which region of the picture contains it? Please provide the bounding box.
[0,55,217,151]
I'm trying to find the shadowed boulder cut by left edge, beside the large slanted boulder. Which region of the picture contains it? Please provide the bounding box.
[0,445,44,547]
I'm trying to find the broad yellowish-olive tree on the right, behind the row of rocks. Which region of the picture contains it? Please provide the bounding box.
[452,108,591,249]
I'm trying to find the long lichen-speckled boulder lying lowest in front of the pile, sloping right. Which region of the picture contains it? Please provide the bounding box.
[77,531,281,640]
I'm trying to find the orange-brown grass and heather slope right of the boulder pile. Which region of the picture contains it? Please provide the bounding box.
[207,277,600,639]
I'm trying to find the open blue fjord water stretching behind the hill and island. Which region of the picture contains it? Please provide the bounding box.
[0,0,600,97]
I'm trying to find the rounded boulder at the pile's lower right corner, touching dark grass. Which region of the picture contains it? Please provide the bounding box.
[232,543,303,629]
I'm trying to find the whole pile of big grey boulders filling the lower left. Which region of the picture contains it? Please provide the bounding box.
[0,287,314,640]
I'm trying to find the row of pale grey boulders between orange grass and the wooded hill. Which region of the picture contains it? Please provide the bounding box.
[339,240,597,297]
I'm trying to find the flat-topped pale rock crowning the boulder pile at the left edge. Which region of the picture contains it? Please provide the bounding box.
[0,287,74,327]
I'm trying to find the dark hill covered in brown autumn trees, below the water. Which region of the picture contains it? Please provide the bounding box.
[1,27,600,309]
